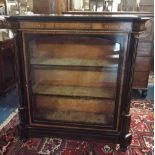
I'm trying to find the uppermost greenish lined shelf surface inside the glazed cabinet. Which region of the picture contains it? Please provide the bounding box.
[31,57,119,68]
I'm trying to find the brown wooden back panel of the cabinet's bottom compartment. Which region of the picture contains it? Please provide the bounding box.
[35,95,115,114]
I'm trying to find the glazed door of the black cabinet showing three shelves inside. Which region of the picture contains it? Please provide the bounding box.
[23,32,128,130]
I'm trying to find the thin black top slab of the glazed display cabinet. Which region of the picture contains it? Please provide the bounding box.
[6,14,149,22]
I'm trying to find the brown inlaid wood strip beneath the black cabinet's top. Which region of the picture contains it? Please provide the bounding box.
[20,21,132,31]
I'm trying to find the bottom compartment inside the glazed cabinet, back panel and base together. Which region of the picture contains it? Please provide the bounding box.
[34,95,114,125]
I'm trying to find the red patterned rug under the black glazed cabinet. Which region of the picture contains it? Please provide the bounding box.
[0,100,154,155]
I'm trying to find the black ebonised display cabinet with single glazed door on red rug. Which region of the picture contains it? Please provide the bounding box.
[6,15,148,150]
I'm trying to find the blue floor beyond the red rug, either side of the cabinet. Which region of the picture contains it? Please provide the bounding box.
[0,84,154,124]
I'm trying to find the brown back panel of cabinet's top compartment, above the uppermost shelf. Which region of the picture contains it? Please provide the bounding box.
[30,36,120,59]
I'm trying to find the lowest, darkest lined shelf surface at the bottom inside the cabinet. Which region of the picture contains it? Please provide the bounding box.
[35,110,113,125]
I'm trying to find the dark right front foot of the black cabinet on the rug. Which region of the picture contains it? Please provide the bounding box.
[120,133,132,152]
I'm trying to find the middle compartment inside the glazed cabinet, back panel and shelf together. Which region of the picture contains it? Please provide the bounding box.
[32,67,117,99]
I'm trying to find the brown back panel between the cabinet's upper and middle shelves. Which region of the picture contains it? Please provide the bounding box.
[31,67,117,88]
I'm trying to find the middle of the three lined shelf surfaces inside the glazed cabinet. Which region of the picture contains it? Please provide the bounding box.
[33,84,115,99]
